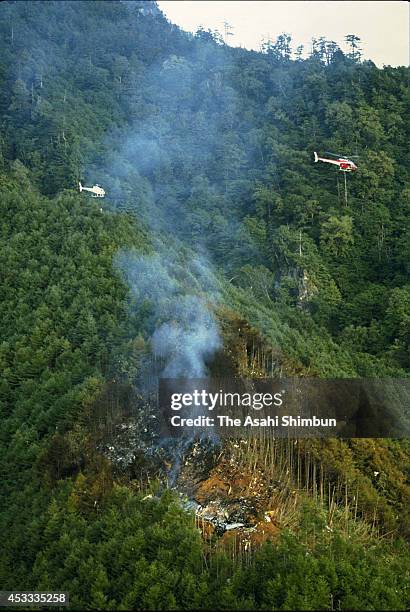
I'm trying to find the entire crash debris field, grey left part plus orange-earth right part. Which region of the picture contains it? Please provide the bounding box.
[96,382,296,552]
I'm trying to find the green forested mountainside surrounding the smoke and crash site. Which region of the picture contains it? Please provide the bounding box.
[0,1,410,610]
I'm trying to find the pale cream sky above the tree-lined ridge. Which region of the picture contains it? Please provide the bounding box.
[158,0,410,67]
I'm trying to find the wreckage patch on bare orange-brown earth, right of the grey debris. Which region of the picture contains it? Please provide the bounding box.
[175,440,297,553]
